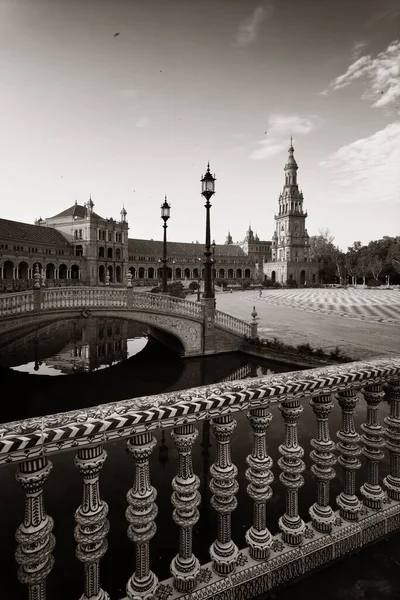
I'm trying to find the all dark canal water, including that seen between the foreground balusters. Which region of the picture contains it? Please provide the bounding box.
[0,319,396,600]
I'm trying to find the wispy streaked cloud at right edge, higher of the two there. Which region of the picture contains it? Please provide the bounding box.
[320,40,400,107]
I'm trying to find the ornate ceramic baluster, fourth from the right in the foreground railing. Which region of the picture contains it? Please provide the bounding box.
[309,394,336,532]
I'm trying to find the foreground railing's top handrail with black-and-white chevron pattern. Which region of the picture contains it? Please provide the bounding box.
[0,357,400,465]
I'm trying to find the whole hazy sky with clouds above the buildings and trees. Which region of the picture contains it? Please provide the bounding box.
[0,0,400,248]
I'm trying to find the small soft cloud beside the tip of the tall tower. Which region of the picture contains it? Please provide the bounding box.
[250,114,321,160]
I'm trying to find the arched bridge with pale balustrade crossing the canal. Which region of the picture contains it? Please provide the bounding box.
[0,287,256,356]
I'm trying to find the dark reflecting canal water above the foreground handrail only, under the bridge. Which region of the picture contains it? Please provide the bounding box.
[0,317,300,424]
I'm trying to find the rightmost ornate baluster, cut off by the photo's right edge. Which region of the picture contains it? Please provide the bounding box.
[383,379,400,500]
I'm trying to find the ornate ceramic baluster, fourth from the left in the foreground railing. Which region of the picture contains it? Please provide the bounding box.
[171,424,201,592]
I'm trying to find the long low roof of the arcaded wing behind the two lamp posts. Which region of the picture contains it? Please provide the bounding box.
[128,239,247,257]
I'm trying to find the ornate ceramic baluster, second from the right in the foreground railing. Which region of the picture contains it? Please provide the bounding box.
[360,385,385,510]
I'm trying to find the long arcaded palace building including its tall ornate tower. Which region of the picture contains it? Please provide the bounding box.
[0,144,318,291]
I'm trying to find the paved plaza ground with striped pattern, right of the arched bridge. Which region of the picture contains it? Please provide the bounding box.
[217,288,400,359]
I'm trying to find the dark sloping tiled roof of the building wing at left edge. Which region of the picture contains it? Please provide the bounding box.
[0,219,70,247]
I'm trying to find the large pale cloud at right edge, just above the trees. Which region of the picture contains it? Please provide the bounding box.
[319,121,400,205]
